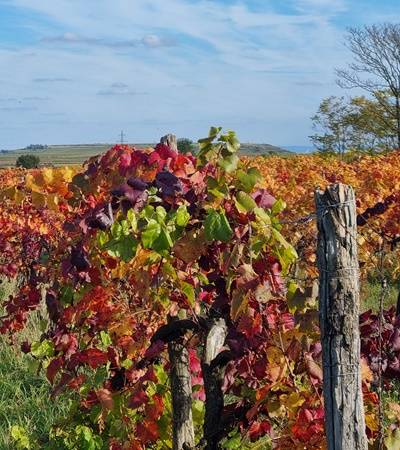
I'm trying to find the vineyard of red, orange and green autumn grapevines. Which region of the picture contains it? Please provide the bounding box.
[0,128,400,450]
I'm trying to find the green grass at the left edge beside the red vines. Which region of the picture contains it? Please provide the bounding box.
[0,283,67,450]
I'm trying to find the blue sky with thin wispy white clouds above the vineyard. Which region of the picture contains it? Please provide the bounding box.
[0,0,400,149]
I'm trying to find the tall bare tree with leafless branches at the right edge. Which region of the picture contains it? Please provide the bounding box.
[336,23,400,148]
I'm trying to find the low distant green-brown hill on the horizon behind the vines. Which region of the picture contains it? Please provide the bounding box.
[0,143,293,167]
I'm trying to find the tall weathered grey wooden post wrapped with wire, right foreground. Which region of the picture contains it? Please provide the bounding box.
[315,184,367,450]
